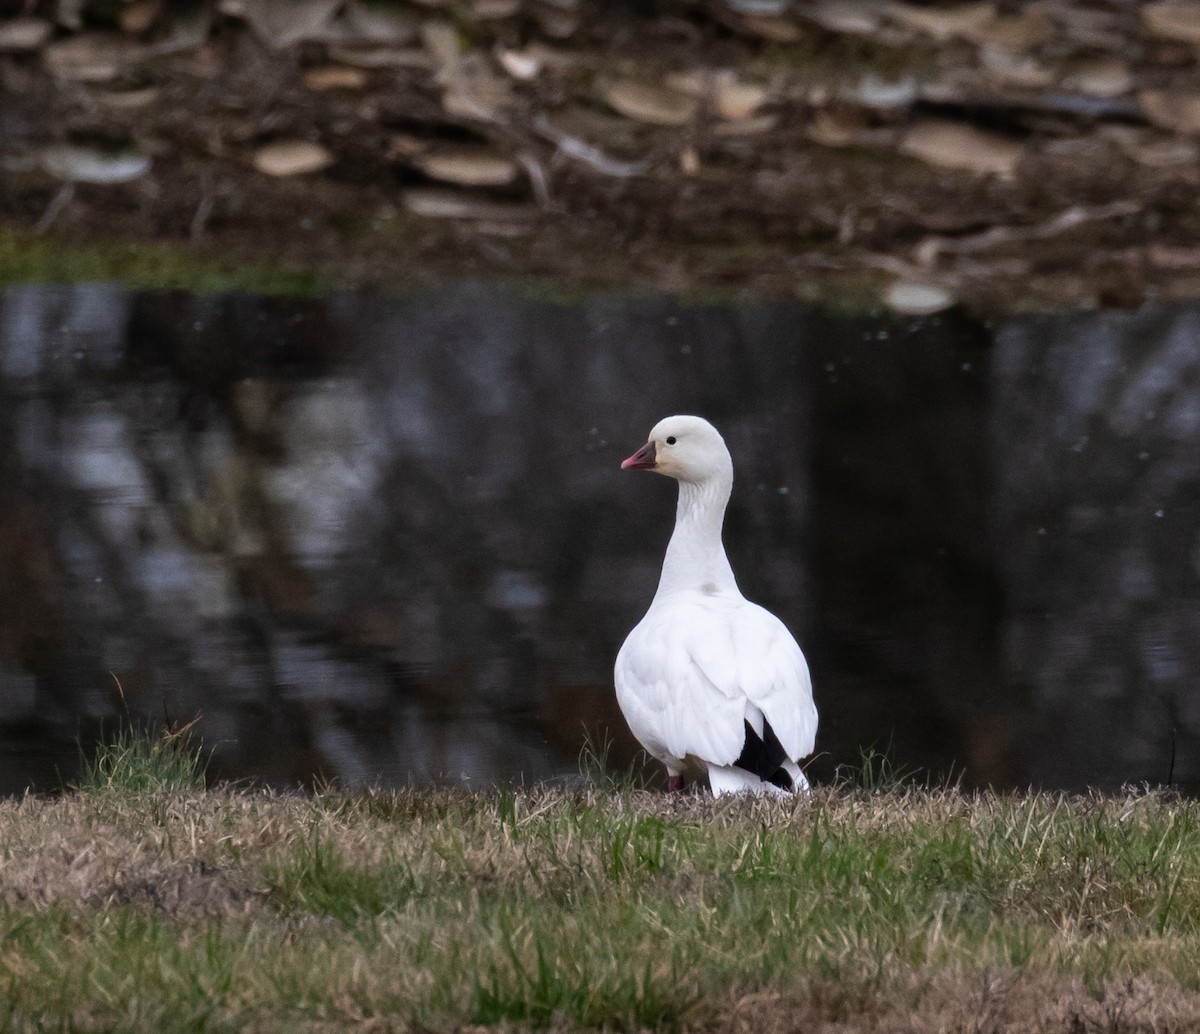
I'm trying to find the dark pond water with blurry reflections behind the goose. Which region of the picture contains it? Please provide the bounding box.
[0,284,1200,792]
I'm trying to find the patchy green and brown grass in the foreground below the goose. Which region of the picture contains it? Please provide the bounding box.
[0,738,1200,1034]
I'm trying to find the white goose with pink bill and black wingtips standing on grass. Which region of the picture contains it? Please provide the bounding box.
[614,416,817,796]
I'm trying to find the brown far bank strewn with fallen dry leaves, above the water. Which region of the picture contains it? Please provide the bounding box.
[0,0,1200,312]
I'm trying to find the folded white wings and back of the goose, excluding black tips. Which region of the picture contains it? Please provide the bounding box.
[616,593,817,765]
